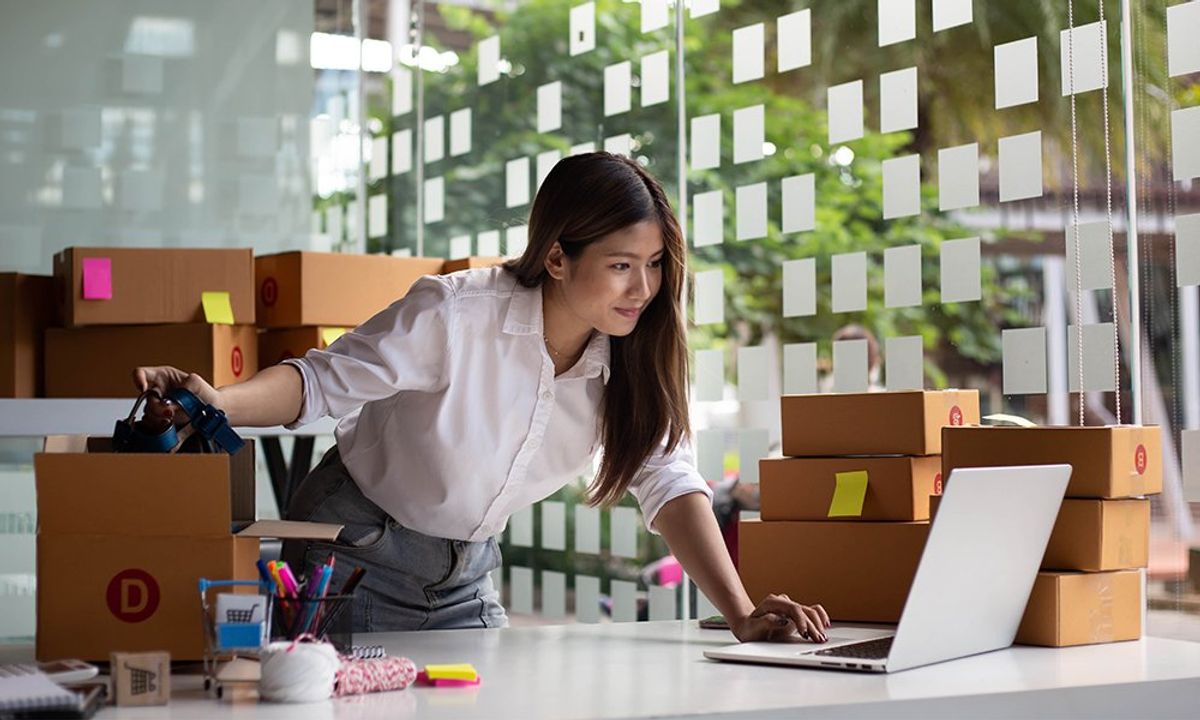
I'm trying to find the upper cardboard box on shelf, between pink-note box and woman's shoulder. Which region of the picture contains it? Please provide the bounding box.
[254,247,444,328]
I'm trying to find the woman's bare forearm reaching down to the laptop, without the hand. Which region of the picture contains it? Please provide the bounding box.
[654,492,755,622]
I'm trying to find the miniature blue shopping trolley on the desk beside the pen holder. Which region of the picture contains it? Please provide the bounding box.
[199,577,275,697]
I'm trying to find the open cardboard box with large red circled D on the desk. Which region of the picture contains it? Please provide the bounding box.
[34,438,341,661]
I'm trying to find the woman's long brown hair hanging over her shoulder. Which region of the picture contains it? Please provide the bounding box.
[504,152,691,505]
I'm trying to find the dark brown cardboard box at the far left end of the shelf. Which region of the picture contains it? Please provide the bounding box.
[0,272,54,397]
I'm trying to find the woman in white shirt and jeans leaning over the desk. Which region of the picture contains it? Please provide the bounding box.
[134,152,829,642]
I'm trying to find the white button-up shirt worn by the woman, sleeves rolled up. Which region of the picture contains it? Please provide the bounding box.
[287,268,712,541]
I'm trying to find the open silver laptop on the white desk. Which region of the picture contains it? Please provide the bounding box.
[704,464,1070,672]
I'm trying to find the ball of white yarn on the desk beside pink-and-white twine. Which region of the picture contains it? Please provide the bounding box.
[258,642,341,702]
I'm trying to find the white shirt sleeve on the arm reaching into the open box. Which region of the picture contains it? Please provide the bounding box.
[284,275,455,430]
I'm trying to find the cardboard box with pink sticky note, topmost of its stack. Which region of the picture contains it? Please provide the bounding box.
[54,247,254,328]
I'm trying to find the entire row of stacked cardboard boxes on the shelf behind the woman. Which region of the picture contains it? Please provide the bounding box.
[0,247,505,398]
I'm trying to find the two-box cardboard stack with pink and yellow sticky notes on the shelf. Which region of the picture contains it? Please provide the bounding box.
[46,247,258,397]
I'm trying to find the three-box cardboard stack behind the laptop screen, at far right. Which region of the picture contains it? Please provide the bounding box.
[935,426,1163,647]
